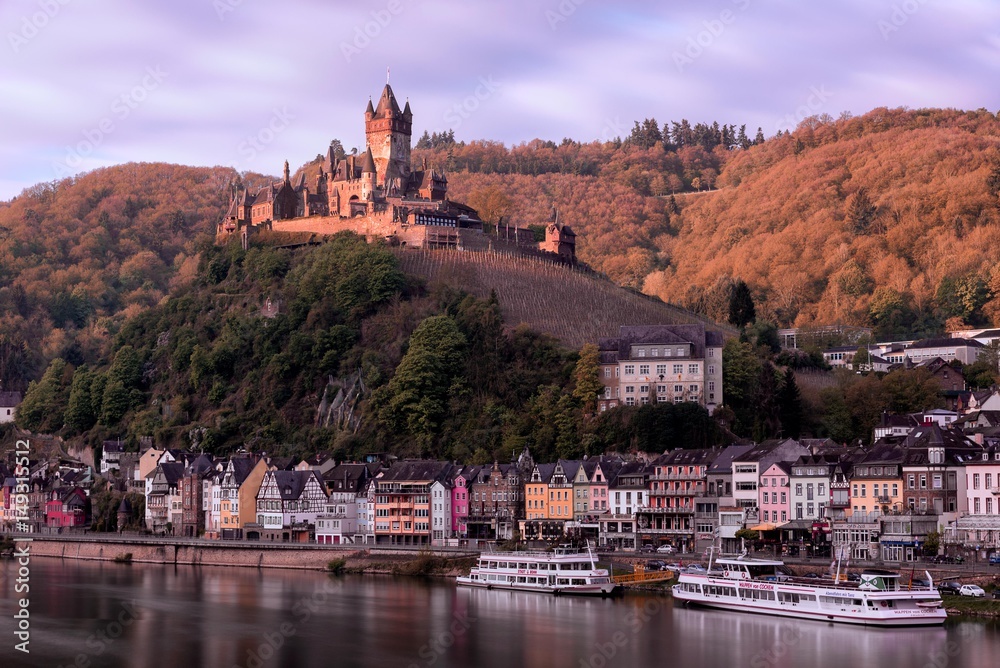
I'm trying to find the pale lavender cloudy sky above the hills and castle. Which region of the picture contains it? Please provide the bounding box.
[0,0,1000,200]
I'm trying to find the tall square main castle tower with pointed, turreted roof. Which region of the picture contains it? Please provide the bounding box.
[365,84,413,188]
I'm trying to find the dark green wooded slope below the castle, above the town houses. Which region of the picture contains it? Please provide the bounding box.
[17,233,724,463]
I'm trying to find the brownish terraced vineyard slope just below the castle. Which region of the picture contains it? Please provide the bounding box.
[395,249,735,350]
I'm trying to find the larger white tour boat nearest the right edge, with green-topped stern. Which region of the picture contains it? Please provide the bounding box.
[673,556,947,626]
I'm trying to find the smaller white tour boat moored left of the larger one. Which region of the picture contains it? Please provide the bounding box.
[456,545,618,596]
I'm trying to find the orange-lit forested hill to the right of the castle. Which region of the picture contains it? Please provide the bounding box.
[428,109,1000,338]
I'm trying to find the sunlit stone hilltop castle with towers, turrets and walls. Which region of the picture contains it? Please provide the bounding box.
[216,83,576,263]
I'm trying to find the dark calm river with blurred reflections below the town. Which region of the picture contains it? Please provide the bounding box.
[0,557,1000,668]
